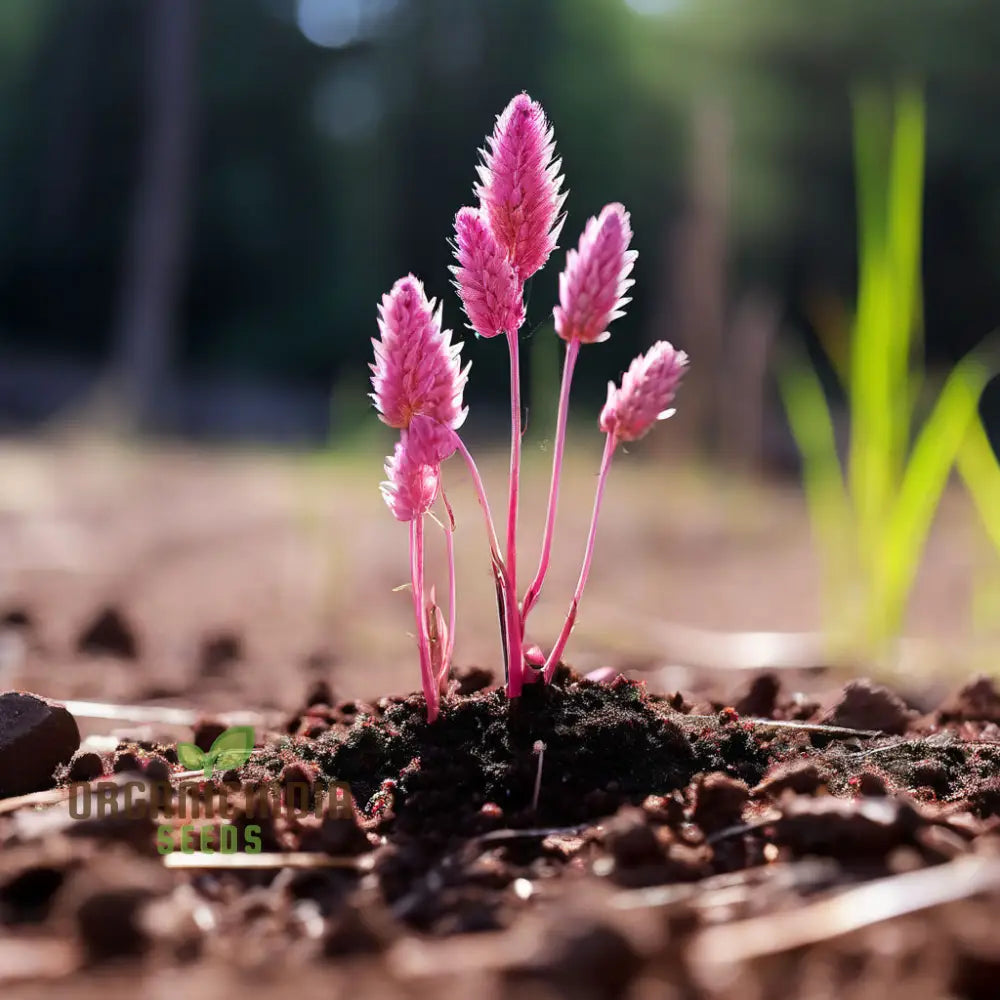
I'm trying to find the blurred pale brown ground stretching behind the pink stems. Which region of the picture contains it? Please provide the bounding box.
[0,431,1000,708]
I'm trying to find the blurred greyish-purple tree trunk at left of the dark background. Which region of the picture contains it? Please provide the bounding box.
[112,0,197,429]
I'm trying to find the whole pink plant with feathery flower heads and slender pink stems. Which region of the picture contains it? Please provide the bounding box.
[371,94,687,721]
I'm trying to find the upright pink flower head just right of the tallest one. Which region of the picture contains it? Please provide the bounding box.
[553,204,638,344]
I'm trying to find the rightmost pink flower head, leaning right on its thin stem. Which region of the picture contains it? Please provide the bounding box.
[600,340,688,441]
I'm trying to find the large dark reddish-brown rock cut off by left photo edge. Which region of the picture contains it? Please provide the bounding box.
[0,691,80,798]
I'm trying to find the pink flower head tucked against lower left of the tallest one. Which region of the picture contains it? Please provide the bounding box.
[451,208,524,337]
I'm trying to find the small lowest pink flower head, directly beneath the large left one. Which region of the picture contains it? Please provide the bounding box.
[381,414,457,521]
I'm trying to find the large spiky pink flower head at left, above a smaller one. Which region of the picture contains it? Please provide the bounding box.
[368,274,469,428]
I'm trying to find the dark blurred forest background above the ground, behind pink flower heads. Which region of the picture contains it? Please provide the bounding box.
[0,0,1000,437]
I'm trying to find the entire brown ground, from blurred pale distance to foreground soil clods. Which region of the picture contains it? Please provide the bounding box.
[0,445,1000,1000]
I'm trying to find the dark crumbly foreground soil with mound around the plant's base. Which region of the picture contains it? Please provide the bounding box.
[0,660,1000,1000]
